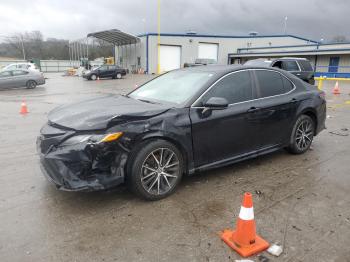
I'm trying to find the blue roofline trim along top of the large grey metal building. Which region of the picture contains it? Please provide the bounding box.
[138,33,318,44]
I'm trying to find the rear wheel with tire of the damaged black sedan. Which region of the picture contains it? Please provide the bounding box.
[287,115,315,154]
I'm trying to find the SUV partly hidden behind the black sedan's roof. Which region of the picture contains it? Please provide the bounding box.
[244,57,315,85]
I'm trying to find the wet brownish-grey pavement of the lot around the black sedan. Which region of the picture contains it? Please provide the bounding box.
[0,74,350,262]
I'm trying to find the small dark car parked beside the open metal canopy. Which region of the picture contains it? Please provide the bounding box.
[83,65,126,80]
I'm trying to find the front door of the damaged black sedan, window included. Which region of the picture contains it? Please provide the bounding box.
[190,70,259,167]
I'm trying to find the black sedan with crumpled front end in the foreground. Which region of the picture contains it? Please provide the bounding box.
[37,66,326,200]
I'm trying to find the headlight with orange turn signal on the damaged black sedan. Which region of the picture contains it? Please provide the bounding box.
[60,132,123,146]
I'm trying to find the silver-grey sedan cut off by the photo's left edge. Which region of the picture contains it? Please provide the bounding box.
[0,69,45,89]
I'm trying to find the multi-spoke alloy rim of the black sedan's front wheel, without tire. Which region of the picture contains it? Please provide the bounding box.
[140,148,180,195]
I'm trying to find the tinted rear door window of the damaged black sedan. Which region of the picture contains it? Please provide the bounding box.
[255,70,285,98]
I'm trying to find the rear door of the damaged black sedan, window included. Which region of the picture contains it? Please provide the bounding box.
[253,69,298,149]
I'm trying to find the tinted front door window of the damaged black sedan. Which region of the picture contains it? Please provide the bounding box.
[202,71,253,104]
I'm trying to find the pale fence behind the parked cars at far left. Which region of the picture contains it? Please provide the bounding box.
[0,60,80,72]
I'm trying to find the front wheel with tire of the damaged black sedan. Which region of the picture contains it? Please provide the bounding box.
[127,140,184,200]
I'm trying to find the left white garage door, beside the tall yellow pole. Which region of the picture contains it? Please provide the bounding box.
[160,45,181,72]
